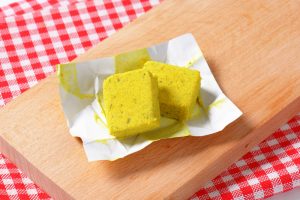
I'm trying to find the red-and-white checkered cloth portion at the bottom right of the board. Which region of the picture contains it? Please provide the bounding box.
[191,113,300,200]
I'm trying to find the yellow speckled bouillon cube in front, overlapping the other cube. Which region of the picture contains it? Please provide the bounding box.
[103,69,160,138]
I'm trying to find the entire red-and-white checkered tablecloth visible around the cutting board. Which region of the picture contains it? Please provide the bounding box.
[0,0,300,200]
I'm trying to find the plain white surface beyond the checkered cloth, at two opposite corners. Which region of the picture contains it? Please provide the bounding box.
[0,0,300,200]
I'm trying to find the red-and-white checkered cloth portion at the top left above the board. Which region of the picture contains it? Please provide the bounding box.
[0,0,159,105]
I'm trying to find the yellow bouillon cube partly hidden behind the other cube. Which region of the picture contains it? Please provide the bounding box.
[144,61,200,121]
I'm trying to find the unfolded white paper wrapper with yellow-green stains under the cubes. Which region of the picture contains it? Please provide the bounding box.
[57,34,242,161]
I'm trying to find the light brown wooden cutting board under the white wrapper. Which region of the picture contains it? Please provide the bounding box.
[0,0,300,199]
